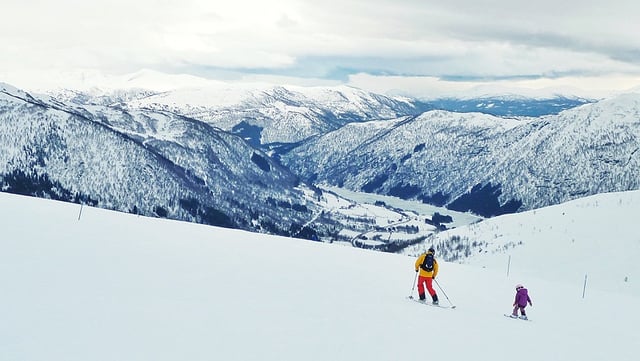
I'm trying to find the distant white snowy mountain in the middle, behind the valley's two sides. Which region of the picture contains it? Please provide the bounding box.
[50,83,424,147]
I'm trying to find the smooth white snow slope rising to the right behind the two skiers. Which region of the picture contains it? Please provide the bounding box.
[403,191,640,296]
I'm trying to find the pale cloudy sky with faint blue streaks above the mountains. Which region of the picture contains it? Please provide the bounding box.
[0,0,640,93]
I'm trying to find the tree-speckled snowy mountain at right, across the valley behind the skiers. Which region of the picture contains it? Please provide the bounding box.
[283,93,640,216]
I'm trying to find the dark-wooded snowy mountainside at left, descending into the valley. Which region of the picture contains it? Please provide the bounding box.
[0,84,314,234]
